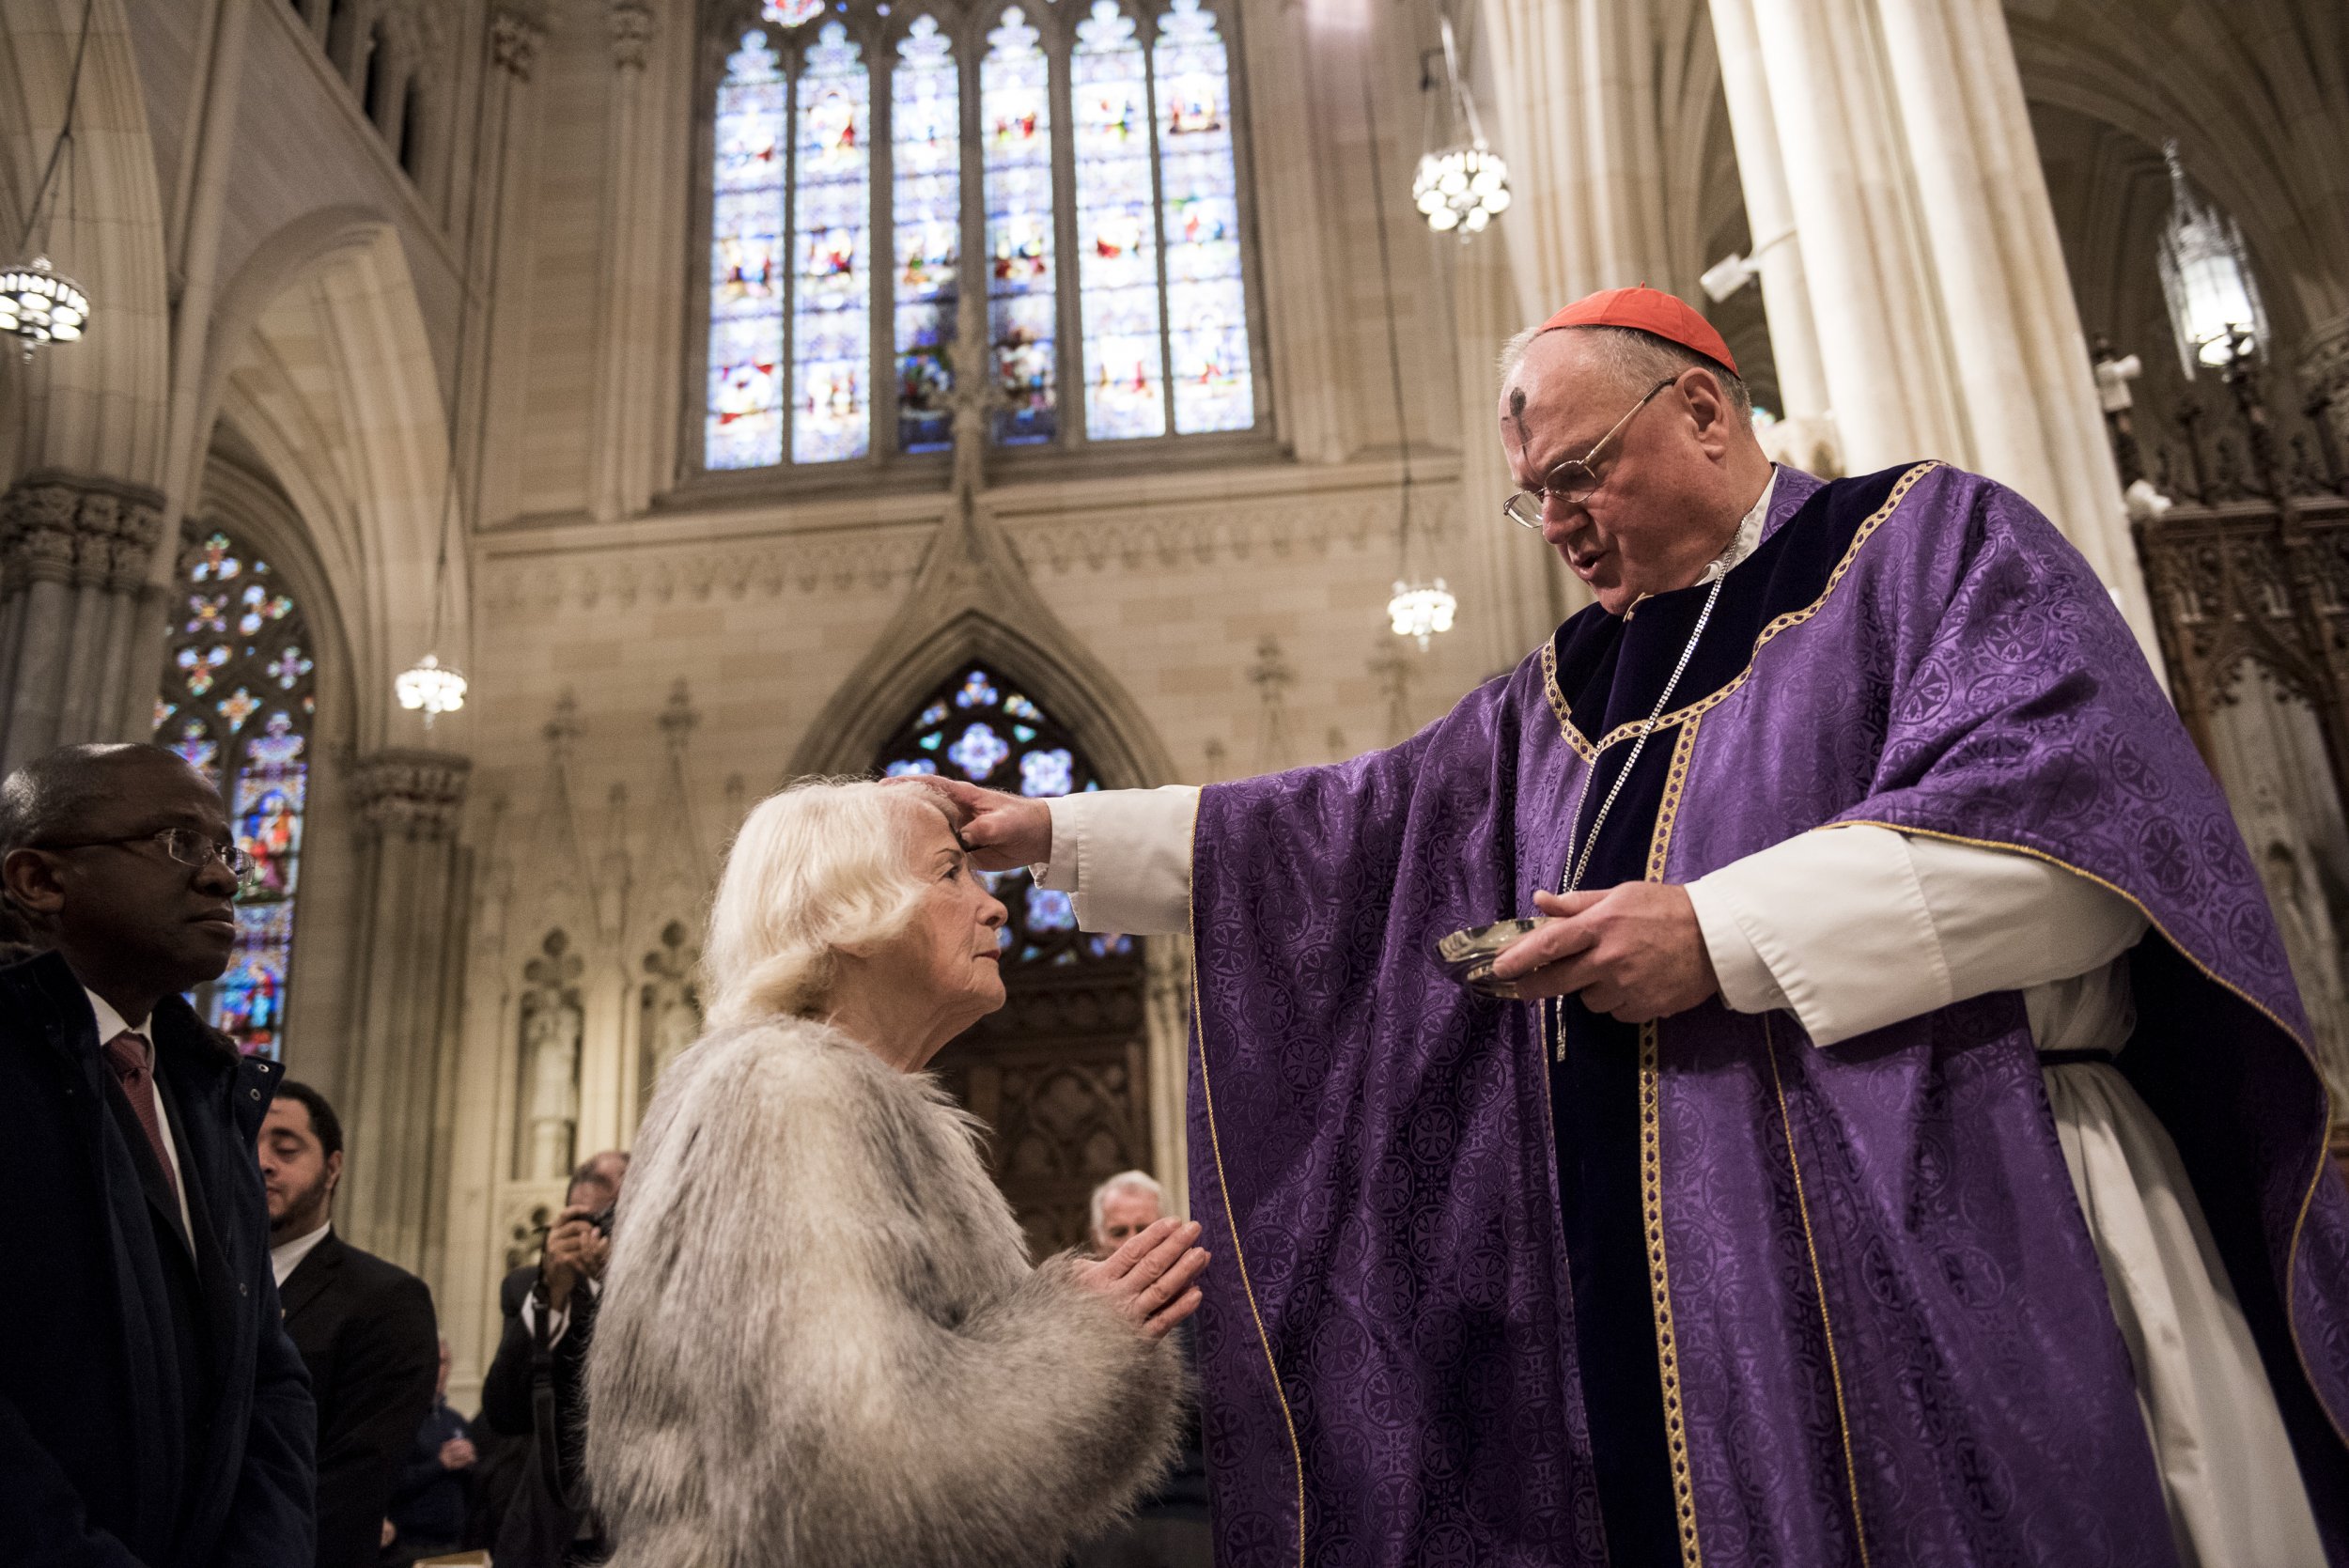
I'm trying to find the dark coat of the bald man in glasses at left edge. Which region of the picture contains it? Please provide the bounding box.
[0,953,313,1568]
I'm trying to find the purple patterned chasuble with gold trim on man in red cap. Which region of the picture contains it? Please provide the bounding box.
[1191,465,2349,1568]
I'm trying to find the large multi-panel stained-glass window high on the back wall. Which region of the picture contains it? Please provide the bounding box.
[693,0,1267,474]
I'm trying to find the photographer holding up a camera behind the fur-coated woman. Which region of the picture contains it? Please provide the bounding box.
[482,1150,628,1568]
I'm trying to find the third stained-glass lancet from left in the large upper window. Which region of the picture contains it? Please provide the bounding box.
[891,16,963,453]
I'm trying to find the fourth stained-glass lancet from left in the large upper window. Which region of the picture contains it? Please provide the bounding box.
[980,5,1057,446]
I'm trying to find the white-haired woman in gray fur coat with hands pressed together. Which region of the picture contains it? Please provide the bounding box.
[587,782,1207,1568]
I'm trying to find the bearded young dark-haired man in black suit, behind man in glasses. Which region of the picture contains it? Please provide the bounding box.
[258,1079,440,1568]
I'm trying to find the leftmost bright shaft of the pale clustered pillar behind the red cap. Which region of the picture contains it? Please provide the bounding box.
[1713,0,1832,437]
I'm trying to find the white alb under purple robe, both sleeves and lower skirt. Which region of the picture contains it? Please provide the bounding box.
[1038,784,2326,1568]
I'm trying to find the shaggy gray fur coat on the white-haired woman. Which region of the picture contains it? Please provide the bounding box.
[587,1018,1182,1568]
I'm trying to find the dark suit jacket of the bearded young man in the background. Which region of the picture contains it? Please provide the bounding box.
[280,1230,440,1568]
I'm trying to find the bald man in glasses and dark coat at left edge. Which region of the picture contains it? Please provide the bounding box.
[0,747,313,1568]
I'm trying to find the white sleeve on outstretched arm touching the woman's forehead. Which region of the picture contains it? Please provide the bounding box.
[1036,784,1198,937]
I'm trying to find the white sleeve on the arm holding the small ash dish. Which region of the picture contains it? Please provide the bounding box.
[1689,826,2145,1045]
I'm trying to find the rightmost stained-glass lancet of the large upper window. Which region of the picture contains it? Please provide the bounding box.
[1151,0,1257,434]
